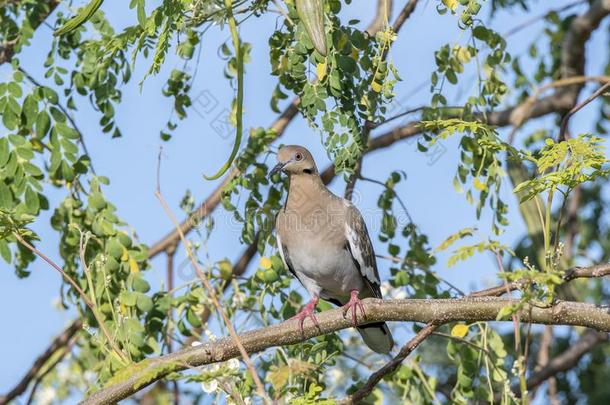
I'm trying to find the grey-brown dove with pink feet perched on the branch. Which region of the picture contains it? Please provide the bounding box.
[270,145,394,353]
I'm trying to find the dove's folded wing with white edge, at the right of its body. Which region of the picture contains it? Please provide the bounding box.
[345,201,381,298]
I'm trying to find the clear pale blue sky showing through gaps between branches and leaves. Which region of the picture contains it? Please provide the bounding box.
[0,0,608,398]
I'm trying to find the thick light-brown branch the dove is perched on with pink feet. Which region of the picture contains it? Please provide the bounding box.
[83,297,610,404]
